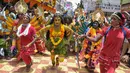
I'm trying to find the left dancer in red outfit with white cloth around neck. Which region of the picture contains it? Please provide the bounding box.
[17,15,36,72]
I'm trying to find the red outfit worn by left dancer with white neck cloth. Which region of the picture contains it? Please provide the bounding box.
[18,26,36,65]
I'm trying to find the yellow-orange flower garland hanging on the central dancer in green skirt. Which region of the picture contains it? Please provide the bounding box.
[50,24,64,46]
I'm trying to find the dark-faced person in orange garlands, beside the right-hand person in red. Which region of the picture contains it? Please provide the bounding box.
[80,21,101,72]
